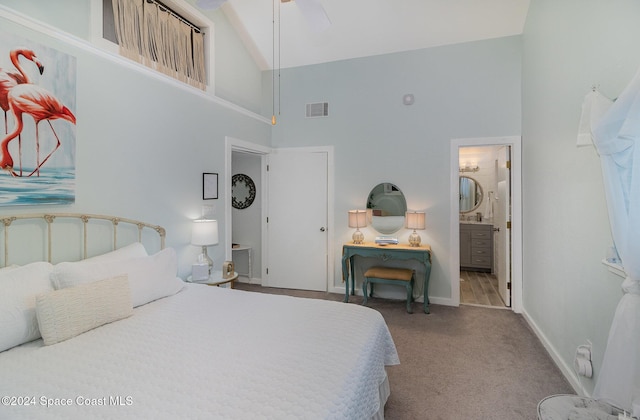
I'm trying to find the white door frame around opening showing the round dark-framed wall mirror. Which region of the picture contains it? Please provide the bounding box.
[223,136,272,283]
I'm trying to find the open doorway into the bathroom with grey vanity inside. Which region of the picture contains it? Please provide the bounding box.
[451,137,522,312]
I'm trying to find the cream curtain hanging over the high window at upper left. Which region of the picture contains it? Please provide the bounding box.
[112,0,207,90]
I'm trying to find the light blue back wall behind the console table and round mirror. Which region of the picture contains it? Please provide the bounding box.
[263,36,521,299]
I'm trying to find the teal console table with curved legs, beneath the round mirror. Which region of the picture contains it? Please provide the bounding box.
[342,242,431,314]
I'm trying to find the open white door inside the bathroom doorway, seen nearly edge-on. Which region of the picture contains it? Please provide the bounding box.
[493,146,511,306]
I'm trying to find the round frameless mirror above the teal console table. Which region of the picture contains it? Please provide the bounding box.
[367,182,407,235]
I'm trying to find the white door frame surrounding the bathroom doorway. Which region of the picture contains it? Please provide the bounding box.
[449,136,523,313]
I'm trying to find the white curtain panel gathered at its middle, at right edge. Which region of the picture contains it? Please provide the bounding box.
[592,72,640,417]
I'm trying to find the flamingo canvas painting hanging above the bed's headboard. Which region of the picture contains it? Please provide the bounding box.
[0,31,77,206]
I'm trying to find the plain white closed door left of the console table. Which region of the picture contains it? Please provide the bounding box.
[265,149,328,291]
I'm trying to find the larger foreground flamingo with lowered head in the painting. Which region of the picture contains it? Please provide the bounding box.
[0,84,76,176]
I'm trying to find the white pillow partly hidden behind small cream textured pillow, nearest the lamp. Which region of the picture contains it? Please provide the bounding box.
[51,248,184,307]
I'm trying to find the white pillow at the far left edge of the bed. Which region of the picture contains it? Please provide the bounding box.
[0,262,53,351]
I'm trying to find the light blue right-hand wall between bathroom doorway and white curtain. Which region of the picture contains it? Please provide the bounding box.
[522,0,640,393]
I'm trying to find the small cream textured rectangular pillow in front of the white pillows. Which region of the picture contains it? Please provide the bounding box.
[36,274,133,346]
